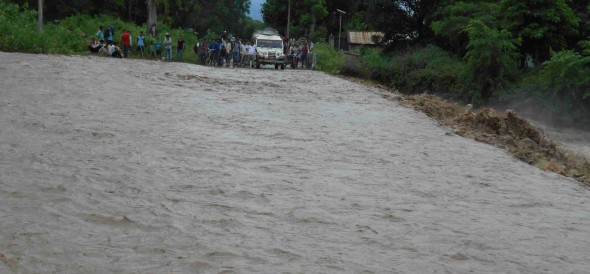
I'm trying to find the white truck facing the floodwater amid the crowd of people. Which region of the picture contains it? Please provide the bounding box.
[252,28,287,69]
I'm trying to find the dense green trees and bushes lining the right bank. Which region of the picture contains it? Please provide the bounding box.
[270,0,590,125]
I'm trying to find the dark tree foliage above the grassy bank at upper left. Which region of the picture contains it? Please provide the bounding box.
[8,0,258,37]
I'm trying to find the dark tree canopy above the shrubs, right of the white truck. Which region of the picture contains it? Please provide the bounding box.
[262,0,590,62]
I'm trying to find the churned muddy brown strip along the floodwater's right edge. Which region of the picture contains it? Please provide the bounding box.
[350,79,590,185]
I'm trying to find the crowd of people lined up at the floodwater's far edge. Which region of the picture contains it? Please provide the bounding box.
[88,26,313,68]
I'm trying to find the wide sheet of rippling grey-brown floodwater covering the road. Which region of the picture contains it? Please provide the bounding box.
[0,52,590,273]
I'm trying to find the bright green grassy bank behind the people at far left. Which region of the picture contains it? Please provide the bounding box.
[0,1,204,63]
